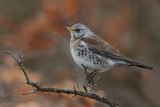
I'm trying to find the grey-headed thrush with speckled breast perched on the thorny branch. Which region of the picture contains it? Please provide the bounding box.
[65,23,153,72]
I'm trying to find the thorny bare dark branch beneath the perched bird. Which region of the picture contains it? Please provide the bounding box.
[4,51,119,107]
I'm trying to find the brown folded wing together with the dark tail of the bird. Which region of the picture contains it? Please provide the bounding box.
[81,36,153,69]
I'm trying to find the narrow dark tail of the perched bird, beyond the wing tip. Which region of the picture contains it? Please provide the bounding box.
[126,60,153,70]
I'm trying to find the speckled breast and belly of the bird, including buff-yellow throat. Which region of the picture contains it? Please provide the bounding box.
[70,38,114,72]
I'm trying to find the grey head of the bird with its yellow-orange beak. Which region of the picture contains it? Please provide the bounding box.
[65,23,94,39]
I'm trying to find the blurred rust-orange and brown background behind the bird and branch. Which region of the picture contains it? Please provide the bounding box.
[0,0,160,107]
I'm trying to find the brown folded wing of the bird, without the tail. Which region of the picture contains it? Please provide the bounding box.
[82,35,129,61]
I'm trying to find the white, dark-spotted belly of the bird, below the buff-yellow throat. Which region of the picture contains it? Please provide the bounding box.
[71,47,116,72]
